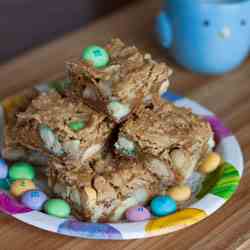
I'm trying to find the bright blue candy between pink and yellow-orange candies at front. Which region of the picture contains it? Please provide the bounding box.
[150,195,176,217]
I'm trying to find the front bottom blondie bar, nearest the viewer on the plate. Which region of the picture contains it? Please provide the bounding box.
[48,155,171,222]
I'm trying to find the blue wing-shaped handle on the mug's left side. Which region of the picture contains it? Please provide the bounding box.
[156,10,172,49]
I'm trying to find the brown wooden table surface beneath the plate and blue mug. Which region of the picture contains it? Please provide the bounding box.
[0,0,250,250]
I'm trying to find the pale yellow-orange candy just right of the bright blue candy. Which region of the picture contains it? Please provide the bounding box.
[167,185,192,202]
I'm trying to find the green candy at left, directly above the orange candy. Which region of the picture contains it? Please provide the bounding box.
[9,162,35,181]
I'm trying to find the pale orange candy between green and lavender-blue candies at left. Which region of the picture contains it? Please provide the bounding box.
[10,179,36,197]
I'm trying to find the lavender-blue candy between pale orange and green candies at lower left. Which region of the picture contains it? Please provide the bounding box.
[21,190,48,210]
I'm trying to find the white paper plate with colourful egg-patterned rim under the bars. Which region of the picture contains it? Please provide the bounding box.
[0,85,244,239]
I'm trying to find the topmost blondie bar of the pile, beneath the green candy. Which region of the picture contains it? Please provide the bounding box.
[66,39,172,123]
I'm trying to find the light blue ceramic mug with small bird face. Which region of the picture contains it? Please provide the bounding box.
[156,0,250,74]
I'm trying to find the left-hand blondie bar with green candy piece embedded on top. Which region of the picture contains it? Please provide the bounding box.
[13,91,113,162]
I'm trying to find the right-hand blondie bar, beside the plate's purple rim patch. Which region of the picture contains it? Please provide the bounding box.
[114,102,214,183]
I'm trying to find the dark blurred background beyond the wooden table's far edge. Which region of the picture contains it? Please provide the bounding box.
[0,0,132,63]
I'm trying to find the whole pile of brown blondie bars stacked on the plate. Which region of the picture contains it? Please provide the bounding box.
[1,39,214,222]
